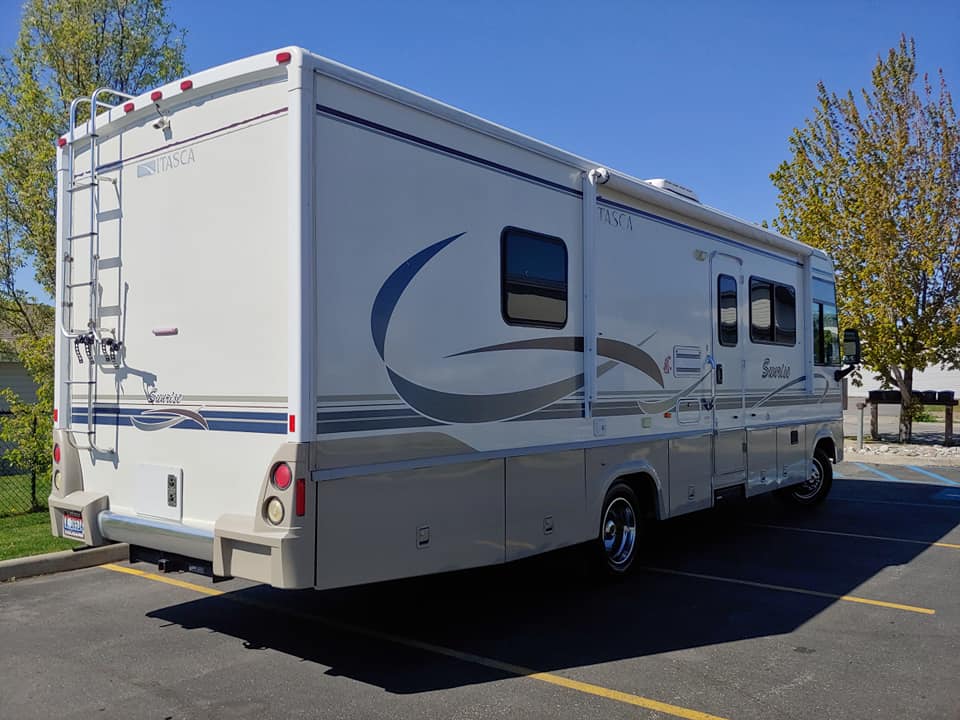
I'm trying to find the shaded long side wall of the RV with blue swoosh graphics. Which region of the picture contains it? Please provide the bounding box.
[311,63,838,587]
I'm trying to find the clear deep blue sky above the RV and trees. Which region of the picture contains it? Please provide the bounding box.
[0,0,960,298]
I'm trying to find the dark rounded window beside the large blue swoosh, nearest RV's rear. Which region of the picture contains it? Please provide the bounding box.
[500,228,567,328]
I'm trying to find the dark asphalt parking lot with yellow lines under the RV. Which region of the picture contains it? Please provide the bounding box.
[0,464,960,720]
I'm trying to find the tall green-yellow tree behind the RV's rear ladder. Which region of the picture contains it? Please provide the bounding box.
[0,0,186,484]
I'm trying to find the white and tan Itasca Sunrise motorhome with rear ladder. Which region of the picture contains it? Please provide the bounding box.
[50,48,853,588]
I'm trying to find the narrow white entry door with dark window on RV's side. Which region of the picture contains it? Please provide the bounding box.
[710,253,748,488]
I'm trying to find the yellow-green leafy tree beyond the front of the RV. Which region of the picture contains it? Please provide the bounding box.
[770,37,960,442]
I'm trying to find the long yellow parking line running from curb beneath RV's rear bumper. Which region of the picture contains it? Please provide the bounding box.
[100,563,724,720]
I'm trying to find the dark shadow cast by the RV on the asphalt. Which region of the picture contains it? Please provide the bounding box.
[149,480,960,693]
